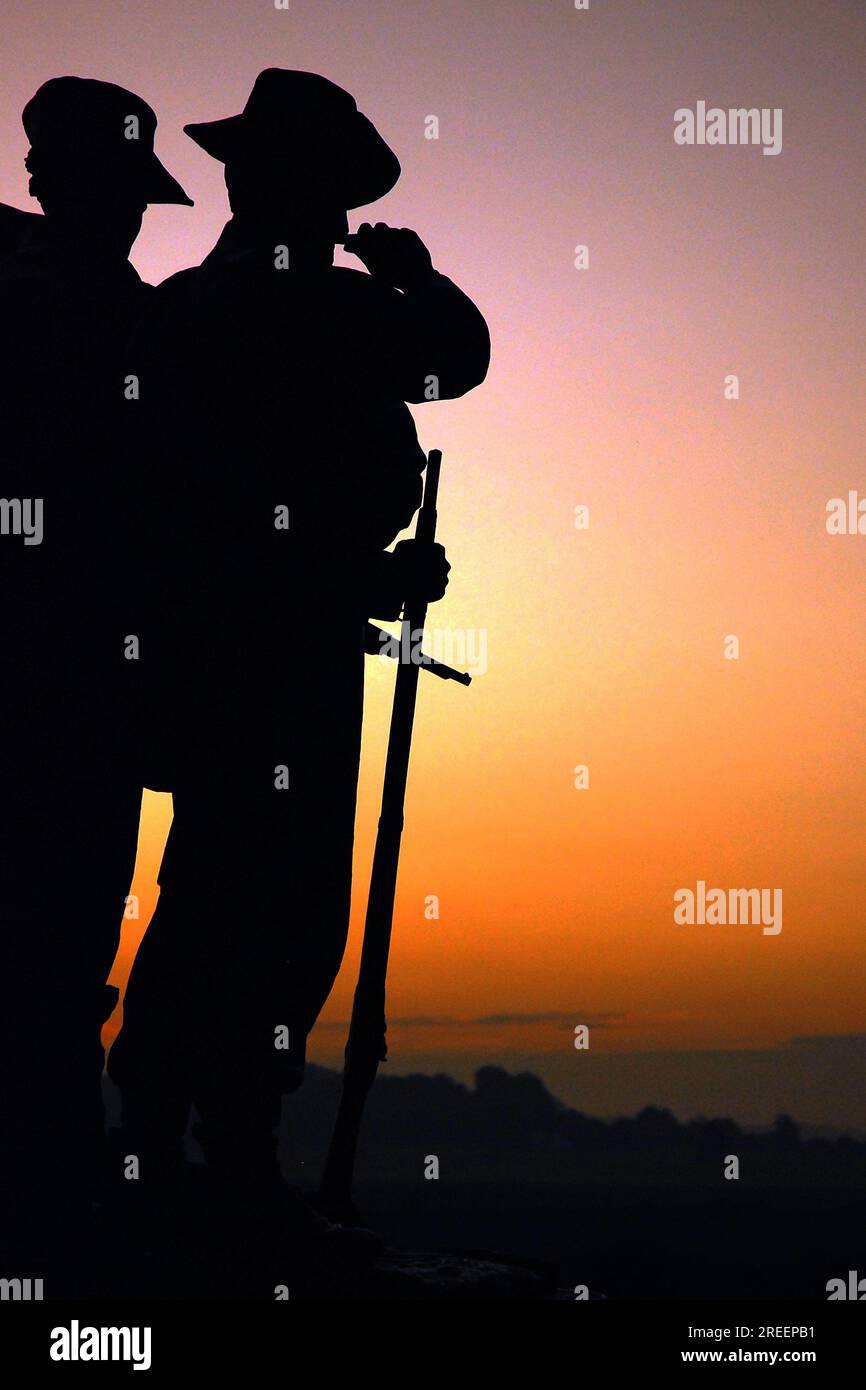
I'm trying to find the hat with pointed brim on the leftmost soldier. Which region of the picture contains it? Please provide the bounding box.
[21,76,193,207]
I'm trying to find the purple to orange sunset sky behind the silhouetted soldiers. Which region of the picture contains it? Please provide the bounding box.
[0,0,866,1129]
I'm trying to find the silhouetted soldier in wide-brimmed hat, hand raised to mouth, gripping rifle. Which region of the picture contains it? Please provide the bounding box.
[110,70,489,1251]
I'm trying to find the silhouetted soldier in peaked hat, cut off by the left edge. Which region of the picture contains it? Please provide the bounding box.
[0,76,190,1273]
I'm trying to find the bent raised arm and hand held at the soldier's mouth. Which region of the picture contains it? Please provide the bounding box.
[345,222,491,404]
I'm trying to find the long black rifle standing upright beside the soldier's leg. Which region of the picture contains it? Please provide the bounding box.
[320,449,468,1220]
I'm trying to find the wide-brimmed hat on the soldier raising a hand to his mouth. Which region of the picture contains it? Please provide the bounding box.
[183,68,400,210]
